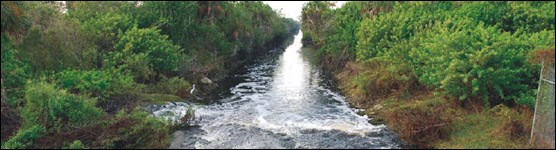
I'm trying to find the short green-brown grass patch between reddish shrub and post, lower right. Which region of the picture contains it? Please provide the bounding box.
[435,105,530,149]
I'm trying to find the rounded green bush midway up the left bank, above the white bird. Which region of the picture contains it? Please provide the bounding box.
[108,27,183,81]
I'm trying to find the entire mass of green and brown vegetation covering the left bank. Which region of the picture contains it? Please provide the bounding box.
[1,1,299,149]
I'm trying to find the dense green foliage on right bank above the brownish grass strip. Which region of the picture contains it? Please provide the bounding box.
[302,2,554,106]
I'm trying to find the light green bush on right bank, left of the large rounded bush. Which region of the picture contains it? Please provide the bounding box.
[356,2,453,62]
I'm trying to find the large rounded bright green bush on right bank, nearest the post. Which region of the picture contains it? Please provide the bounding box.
[411,21,534,105]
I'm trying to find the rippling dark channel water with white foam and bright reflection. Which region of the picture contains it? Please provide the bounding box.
[146,33,401,148]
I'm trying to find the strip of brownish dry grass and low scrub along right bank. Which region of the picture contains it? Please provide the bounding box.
[335,60,533,149]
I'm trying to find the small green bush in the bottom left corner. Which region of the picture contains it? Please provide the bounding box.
[2,125,45,149]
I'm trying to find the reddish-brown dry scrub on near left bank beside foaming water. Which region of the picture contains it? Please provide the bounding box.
[27,111,172,149]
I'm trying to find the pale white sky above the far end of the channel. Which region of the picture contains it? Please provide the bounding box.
[263,1,346,21]
